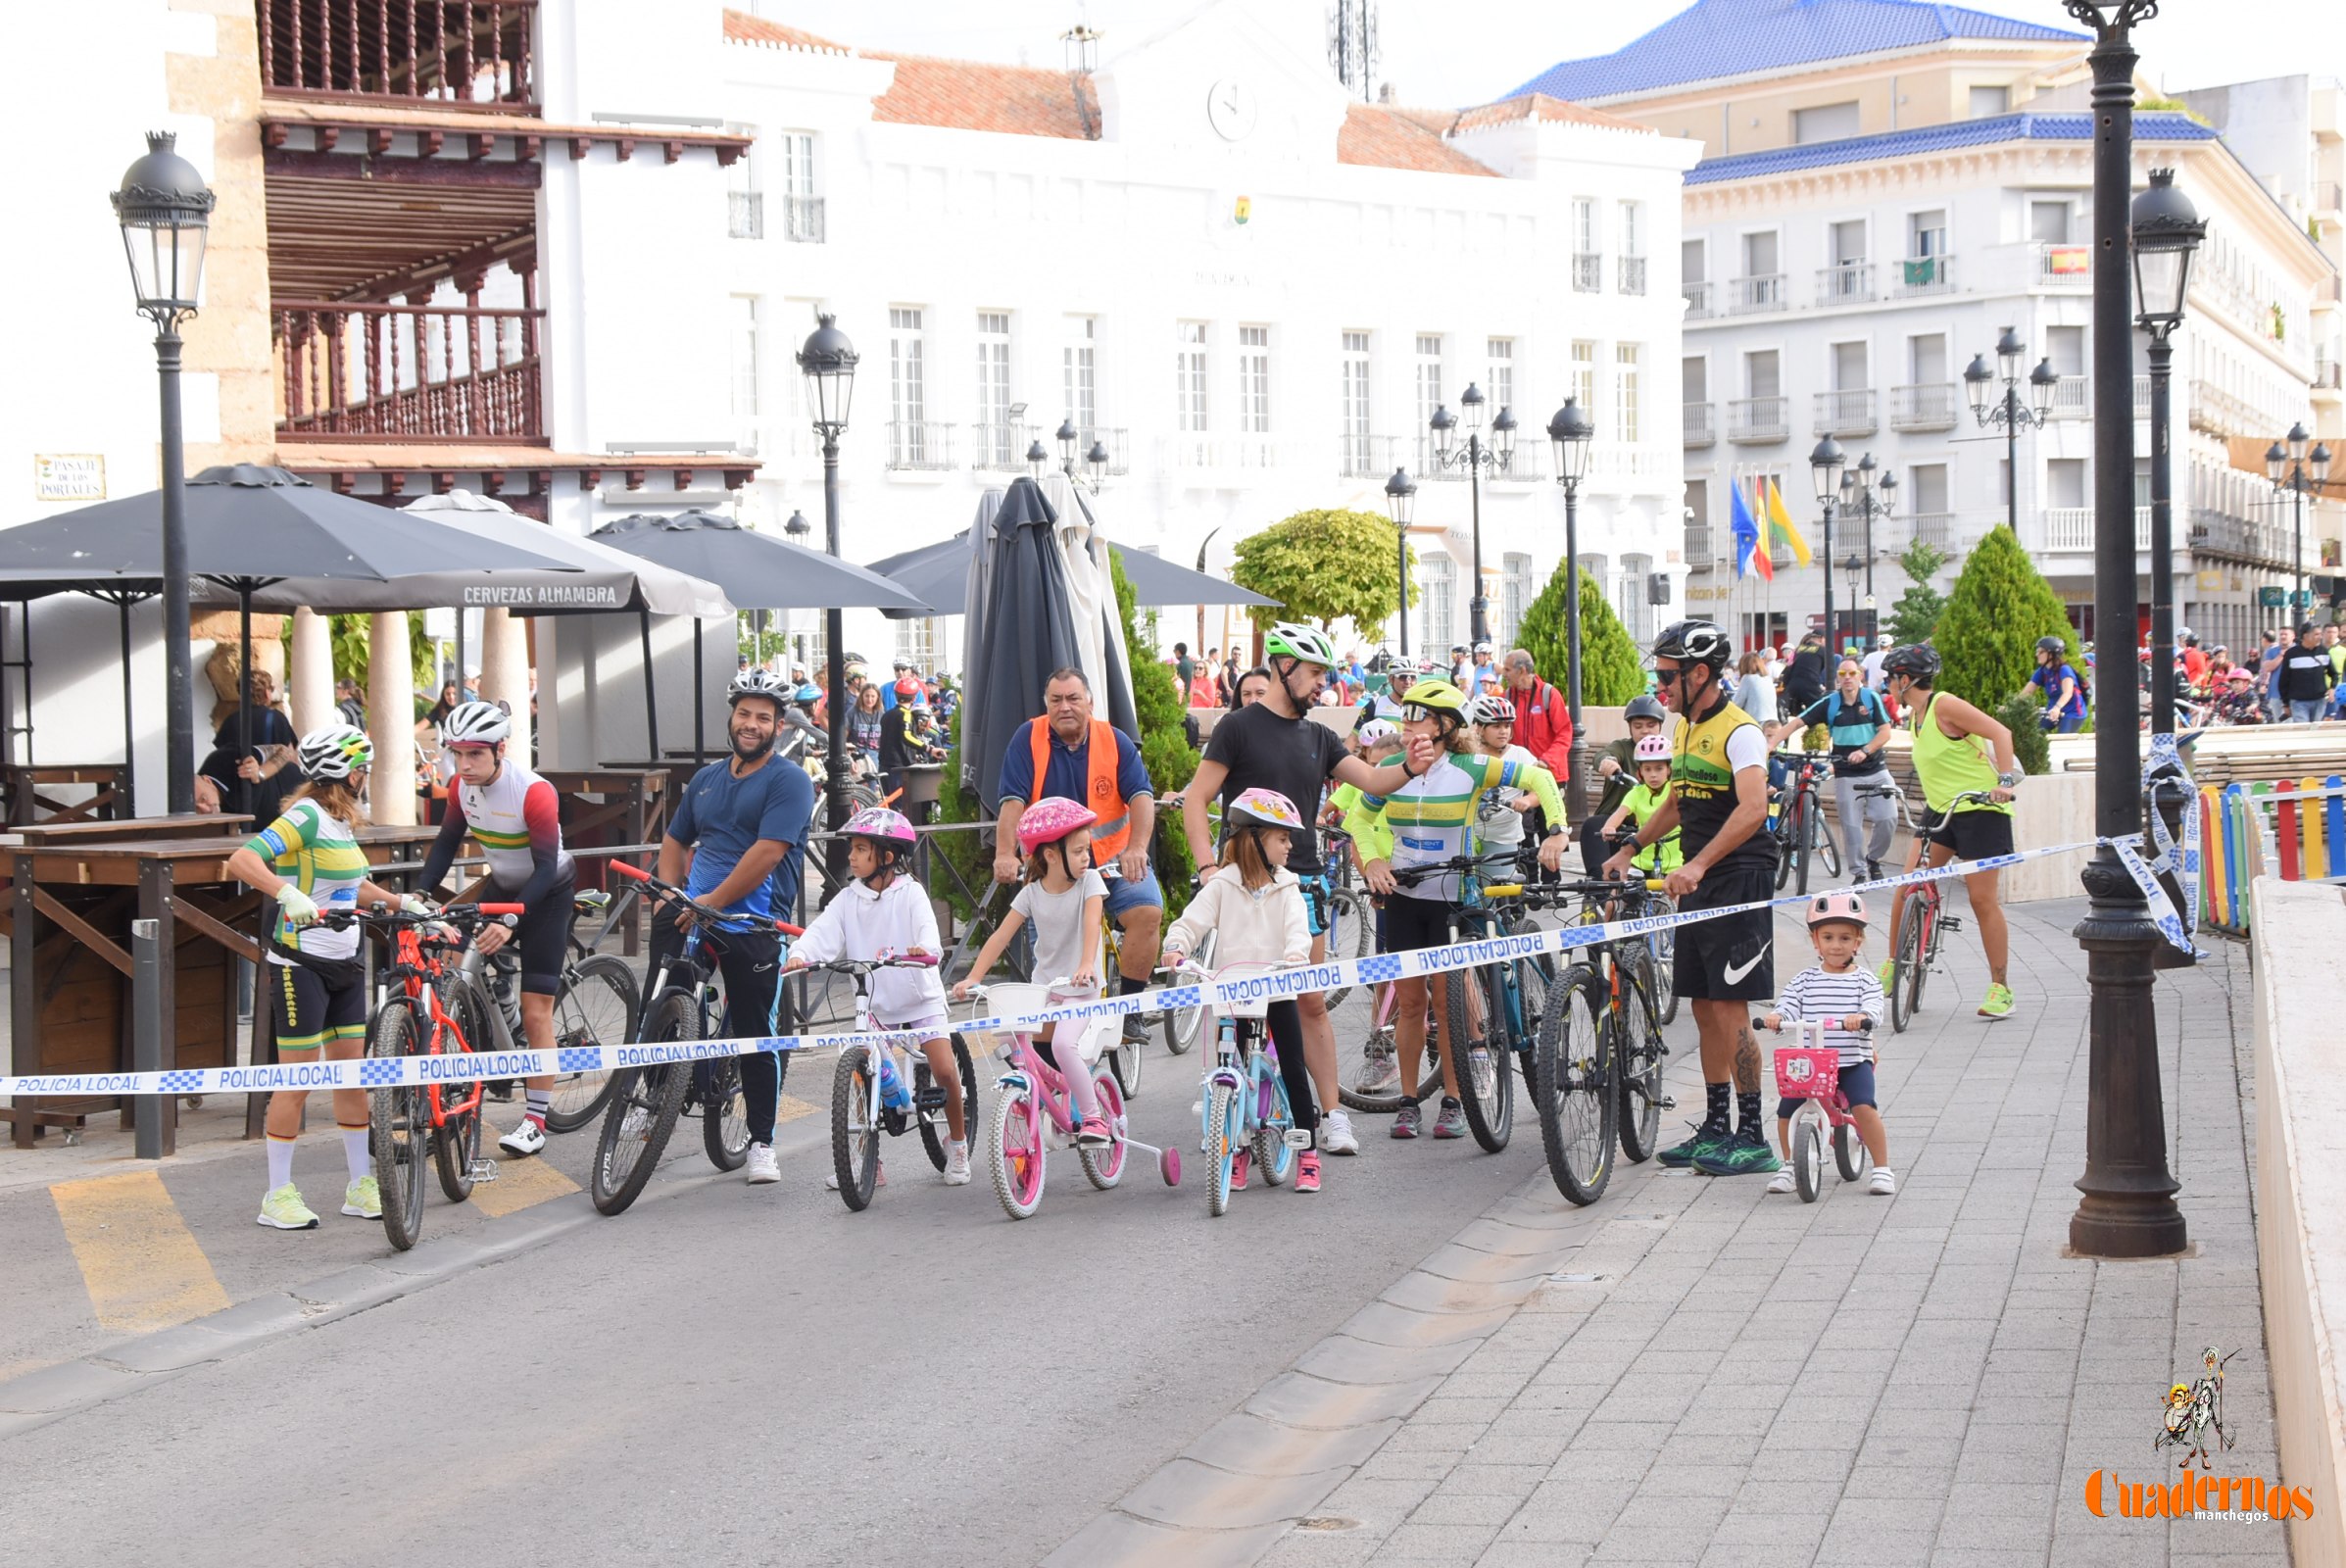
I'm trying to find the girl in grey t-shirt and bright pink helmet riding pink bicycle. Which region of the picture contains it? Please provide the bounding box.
[953,796,1114,1148]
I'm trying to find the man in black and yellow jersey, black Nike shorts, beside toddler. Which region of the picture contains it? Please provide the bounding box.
[1604,619,1781,1176]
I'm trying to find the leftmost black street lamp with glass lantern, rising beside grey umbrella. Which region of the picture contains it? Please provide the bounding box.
[113,131,213,817]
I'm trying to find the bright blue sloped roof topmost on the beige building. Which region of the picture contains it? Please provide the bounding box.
[1506,0,2092,101]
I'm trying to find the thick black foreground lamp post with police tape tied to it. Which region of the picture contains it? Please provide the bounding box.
[2065,0,2189,1258]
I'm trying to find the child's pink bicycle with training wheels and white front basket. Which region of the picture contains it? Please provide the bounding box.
[969,981,1180,1221]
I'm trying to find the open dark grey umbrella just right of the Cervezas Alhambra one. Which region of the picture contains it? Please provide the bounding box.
[589,507,929,762]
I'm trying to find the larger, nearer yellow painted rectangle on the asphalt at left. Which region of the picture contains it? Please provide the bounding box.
[49,1171,230,1333]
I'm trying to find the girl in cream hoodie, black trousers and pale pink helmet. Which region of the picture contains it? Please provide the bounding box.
[1163,789,1318,1193]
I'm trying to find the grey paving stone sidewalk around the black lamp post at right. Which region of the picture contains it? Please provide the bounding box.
[1049,892,2287,1568]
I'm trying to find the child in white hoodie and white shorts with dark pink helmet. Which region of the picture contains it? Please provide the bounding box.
[784,806,969,1193]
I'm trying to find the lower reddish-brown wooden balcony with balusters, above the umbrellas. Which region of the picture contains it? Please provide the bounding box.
[269,301,547,446]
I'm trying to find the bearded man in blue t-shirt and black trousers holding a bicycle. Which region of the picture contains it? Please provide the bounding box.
[653,666,814,1183]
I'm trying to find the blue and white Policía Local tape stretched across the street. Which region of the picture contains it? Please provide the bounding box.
[0,836,2191,1094]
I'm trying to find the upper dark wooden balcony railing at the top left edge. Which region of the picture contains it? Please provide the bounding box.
[254,0,540,115]
